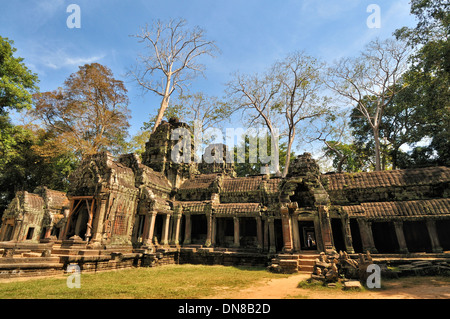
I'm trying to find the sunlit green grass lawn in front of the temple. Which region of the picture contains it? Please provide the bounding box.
[0,265,286,299]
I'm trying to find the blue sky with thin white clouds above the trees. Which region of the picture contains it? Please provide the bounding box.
[0,0,415,154]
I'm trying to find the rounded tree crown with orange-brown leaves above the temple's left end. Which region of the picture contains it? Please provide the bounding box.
[32,63,130,158]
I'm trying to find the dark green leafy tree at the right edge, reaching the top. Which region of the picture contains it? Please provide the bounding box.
[395,0,450,167]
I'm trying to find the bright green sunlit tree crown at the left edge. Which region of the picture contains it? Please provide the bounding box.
[0,36,38,113]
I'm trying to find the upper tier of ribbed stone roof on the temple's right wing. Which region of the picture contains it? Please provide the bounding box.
[325,166,450,191]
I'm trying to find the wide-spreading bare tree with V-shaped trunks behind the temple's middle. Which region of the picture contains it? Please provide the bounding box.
[228,52,328,176]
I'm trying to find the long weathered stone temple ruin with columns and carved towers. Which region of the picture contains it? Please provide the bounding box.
[0,120,450,277]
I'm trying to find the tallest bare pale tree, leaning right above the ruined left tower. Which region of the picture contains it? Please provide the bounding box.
[129,19,218,131]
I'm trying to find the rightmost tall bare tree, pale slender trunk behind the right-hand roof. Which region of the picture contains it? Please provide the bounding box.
[326,39,409,170]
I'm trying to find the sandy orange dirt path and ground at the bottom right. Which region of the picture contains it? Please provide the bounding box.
[213,274,450,299]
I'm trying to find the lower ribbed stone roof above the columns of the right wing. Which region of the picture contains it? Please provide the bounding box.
[342,198,450,219]
